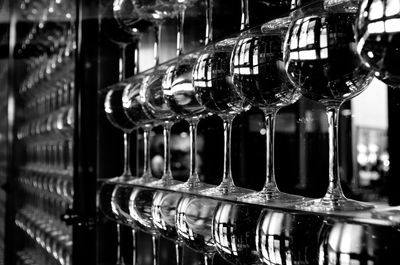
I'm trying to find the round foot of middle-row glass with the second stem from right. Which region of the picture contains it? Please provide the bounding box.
[239,191,305,206]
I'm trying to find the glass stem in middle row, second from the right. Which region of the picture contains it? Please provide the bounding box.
[263,111,279,194]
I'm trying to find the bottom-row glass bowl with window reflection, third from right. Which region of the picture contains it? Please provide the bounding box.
[212,202,261,264]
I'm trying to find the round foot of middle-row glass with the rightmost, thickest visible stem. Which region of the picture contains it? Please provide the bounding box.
[295,197,374,212]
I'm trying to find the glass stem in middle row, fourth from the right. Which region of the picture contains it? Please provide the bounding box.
[187,118,200,186]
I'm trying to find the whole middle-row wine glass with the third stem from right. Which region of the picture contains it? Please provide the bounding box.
[193,37,249,196]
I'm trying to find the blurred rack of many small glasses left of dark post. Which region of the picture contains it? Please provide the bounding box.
[11,5,75,265]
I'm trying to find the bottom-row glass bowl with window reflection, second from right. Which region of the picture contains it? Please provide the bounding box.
[256,210,323,264]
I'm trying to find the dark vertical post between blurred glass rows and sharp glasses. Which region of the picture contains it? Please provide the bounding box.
[72,0,100,264]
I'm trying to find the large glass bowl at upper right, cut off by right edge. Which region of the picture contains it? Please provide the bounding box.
[355,0,400,87]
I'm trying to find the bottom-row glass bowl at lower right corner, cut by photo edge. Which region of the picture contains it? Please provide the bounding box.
[318,220,400,265]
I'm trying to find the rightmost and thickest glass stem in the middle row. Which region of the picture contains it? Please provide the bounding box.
[324,106,344,200]
